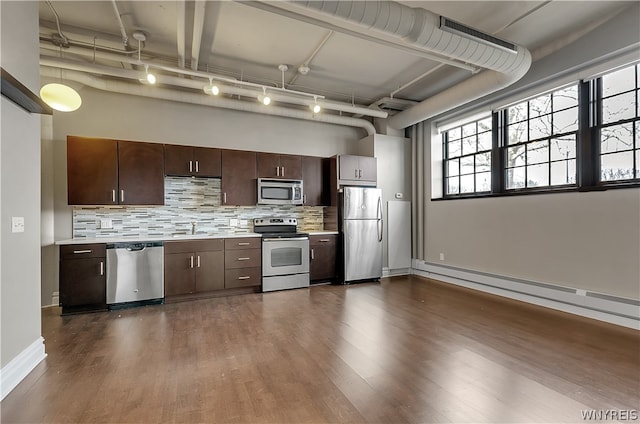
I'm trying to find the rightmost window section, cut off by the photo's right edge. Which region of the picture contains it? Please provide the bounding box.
[596,65,640,182]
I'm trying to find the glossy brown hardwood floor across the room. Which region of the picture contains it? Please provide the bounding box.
[1,277,640,424]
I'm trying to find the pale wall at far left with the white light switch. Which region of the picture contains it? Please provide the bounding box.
[0,1,44,388]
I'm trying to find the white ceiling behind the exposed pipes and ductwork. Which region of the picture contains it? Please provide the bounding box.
[40,0,632,112]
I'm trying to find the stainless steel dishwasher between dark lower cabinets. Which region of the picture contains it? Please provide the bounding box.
[107,241,164,308]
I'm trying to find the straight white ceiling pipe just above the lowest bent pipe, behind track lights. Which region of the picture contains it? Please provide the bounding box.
[40,56,388,118]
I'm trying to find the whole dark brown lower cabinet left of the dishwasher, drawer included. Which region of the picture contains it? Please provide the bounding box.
[59,244,107,315]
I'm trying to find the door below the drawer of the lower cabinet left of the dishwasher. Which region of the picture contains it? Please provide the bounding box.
[60,258,107,309]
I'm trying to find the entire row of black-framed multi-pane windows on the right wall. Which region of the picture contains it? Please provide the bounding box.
[442,63,640,198]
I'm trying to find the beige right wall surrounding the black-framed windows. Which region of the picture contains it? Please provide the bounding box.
[419,3,640,299]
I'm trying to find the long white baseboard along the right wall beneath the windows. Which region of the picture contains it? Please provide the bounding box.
[413,259,640,330]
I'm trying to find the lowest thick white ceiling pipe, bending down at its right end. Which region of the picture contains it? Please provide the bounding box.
[40,67,375,135]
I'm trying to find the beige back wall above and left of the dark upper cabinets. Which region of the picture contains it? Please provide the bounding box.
[42,87,365,306]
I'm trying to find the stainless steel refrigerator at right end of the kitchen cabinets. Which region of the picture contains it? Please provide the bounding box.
[338,187,383,284]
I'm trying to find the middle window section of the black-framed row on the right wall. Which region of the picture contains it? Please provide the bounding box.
[504,85,578,189]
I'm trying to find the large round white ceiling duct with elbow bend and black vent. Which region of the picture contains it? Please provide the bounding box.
[282,0,531,128]
